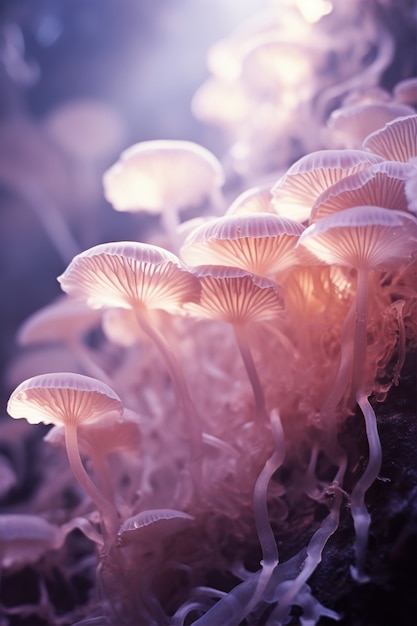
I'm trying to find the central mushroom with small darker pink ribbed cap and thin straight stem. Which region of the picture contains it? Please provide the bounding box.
[186,266,284,424]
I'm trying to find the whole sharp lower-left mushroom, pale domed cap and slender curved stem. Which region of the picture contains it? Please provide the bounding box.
[7,372,123,538]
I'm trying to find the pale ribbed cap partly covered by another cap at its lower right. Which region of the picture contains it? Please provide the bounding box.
[272,150,383,222]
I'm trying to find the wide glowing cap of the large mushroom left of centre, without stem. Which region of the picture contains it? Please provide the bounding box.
[58,241,199,313]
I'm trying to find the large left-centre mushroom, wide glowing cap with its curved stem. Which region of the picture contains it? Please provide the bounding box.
[58,242,201,460]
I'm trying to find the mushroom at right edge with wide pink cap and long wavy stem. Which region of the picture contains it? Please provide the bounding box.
[298,206,417,581]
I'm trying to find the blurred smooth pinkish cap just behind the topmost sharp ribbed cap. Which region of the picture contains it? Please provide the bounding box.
[327,102,414,148]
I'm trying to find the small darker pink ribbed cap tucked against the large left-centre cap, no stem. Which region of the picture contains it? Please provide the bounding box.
[186,265,284,324]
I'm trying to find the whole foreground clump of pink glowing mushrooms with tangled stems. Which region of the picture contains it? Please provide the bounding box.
[0,4,417,626]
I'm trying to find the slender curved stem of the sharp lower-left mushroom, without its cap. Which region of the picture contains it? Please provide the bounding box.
[65,424,120,538]
